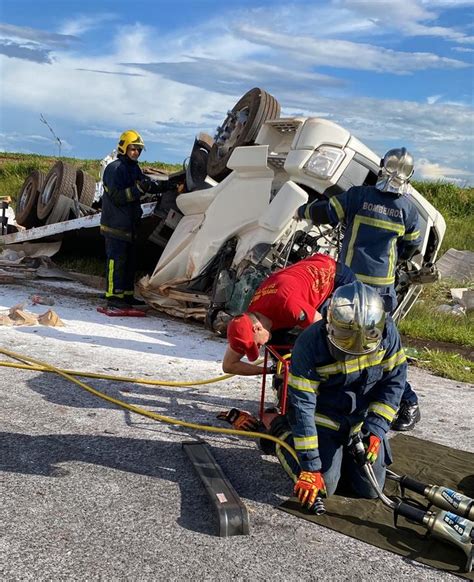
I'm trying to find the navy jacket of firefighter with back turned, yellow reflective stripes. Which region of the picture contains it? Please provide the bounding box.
[298,186,421,287]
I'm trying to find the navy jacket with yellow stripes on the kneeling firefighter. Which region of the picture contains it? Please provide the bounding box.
[288,318,407,471]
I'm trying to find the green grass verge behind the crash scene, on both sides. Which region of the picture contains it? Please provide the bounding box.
[0,154,474,382]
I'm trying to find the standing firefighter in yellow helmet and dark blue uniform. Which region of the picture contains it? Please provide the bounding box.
[100,130,160,309]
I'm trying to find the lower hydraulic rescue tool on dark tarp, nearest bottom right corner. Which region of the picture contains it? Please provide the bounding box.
[352,435,474,572]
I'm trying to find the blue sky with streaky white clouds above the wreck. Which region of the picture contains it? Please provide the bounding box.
[0,0,474,185]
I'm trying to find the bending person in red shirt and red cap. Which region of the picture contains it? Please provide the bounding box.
[222,253,355,376]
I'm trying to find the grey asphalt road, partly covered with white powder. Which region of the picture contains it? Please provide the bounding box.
[0,286,474,581]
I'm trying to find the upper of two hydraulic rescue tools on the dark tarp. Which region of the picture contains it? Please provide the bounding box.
[387,469,474,520]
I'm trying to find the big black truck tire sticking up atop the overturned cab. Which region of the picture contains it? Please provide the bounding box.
[207,87,280,181]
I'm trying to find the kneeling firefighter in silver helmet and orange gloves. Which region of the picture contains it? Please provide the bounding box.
[270,281,407,507]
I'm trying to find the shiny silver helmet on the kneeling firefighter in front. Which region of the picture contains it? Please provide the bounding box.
[327,281,385,356]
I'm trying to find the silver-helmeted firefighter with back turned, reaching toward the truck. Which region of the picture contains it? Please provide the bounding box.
[297,148,421,431]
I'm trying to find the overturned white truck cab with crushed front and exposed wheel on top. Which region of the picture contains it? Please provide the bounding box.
[139,89,446,333]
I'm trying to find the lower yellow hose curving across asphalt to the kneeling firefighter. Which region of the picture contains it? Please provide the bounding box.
[0,348,298,461]
